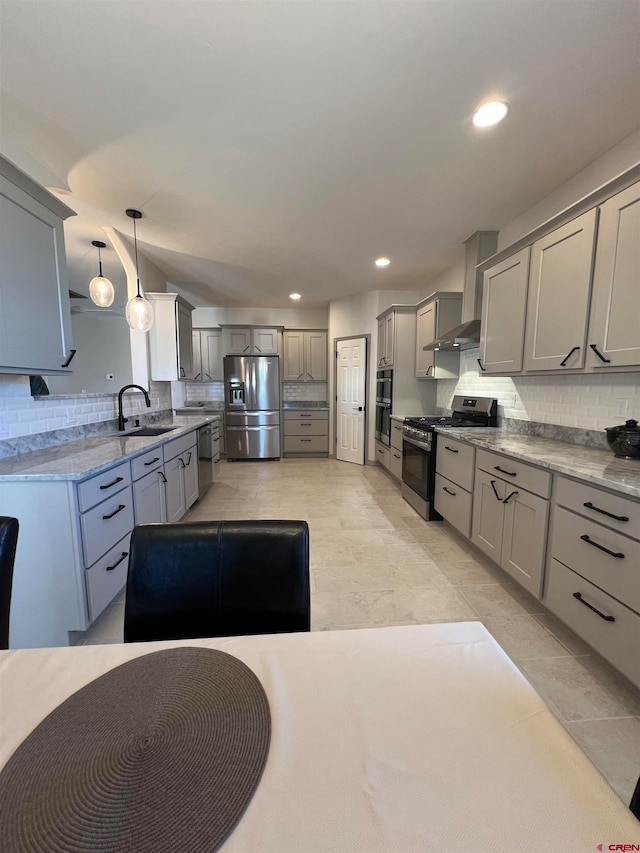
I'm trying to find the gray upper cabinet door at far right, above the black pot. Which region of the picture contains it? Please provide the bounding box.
[587,183,640,368]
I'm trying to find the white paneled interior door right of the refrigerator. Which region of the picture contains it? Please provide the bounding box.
[336,338,367,465]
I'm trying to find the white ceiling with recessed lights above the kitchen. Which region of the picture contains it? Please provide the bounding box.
[0,0,640,307]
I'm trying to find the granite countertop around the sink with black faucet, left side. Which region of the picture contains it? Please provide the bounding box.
[0,414,215,488]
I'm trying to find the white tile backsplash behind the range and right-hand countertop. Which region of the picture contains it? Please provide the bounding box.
[437,347,640,430]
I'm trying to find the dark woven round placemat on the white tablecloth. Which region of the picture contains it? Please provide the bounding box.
[0,647,271,853]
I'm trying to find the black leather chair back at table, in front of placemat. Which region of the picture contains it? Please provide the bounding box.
[124,521,311,643]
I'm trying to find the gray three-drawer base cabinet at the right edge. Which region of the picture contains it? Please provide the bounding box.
[543,477,640,687]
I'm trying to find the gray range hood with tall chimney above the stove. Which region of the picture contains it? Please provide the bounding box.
[423,231,498,350]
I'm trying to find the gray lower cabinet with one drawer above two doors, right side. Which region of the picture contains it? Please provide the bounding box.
[471,450,551,598]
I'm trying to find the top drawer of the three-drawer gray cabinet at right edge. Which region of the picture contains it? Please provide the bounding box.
[556,477,640,539]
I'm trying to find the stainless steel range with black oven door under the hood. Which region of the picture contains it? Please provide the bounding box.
[402,395,498,521]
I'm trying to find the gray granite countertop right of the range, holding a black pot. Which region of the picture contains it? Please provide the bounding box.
[436,427,640,498]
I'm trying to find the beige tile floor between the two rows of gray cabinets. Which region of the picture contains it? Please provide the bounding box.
[81,459,640,803]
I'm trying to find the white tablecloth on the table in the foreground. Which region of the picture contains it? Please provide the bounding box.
[0,622,640,853]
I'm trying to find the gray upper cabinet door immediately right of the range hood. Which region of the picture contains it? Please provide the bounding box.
[480,246,531,373]
